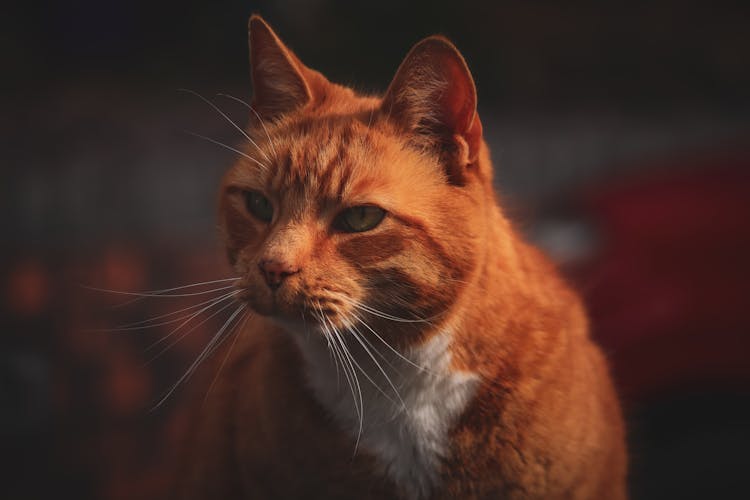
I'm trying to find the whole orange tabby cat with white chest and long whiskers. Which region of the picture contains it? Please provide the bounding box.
[180,16,626,499]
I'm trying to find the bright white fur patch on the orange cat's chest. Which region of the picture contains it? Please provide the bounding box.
[294,331,478,498]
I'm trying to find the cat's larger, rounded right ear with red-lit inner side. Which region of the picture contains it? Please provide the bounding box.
[382,36,482,184]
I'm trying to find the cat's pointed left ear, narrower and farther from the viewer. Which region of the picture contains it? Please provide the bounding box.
[248,14,322,118]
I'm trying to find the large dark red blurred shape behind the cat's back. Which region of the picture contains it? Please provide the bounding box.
[581,154,750,401]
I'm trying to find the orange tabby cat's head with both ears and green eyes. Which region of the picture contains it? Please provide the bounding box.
[220,16,492,345]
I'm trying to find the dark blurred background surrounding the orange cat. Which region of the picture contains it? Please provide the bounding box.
[0,0,750,499]
